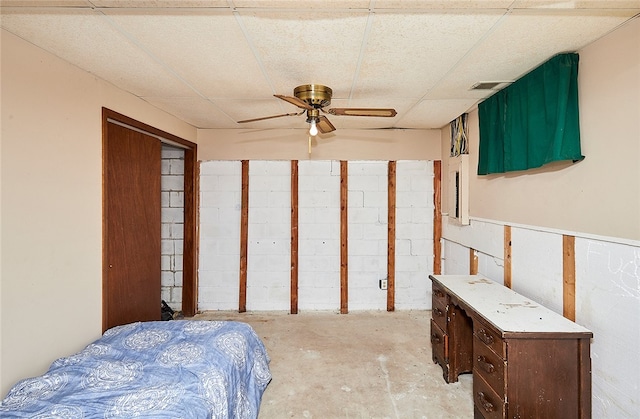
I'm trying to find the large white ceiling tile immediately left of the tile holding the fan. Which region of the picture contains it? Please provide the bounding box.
[107,10,273,100]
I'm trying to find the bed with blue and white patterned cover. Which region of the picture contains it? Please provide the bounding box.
[0,320,271,419]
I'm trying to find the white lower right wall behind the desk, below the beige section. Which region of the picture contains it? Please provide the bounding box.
[442,219,640,418]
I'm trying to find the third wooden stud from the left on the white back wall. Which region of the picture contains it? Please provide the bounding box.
[340,161,349,314]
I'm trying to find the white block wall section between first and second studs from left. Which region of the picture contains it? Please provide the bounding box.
[247,160,291,310]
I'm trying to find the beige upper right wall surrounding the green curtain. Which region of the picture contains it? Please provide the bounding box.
[442,19,640,240]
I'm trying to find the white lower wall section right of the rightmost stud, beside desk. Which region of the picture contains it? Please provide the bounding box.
[575,238,640,418]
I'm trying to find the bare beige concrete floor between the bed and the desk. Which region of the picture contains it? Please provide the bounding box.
[194,311,473,419]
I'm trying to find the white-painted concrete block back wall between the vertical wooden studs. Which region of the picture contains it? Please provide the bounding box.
[198,161,433,311]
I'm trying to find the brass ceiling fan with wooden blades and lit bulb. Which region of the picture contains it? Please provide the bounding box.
[238,84,397,136]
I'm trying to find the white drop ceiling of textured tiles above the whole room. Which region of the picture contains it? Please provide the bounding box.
[0,0,640,129]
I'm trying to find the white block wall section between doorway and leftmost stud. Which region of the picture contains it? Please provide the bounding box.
[198,161,242,310]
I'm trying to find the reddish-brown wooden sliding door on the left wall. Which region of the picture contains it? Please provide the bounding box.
[103,122,162,330]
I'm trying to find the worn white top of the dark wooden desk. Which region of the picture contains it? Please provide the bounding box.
[429,275,593,337]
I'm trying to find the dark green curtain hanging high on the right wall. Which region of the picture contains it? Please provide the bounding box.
[478,53,584,175]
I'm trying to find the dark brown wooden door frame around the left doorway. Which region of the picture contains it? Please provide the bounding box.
[102,107,199,331]
